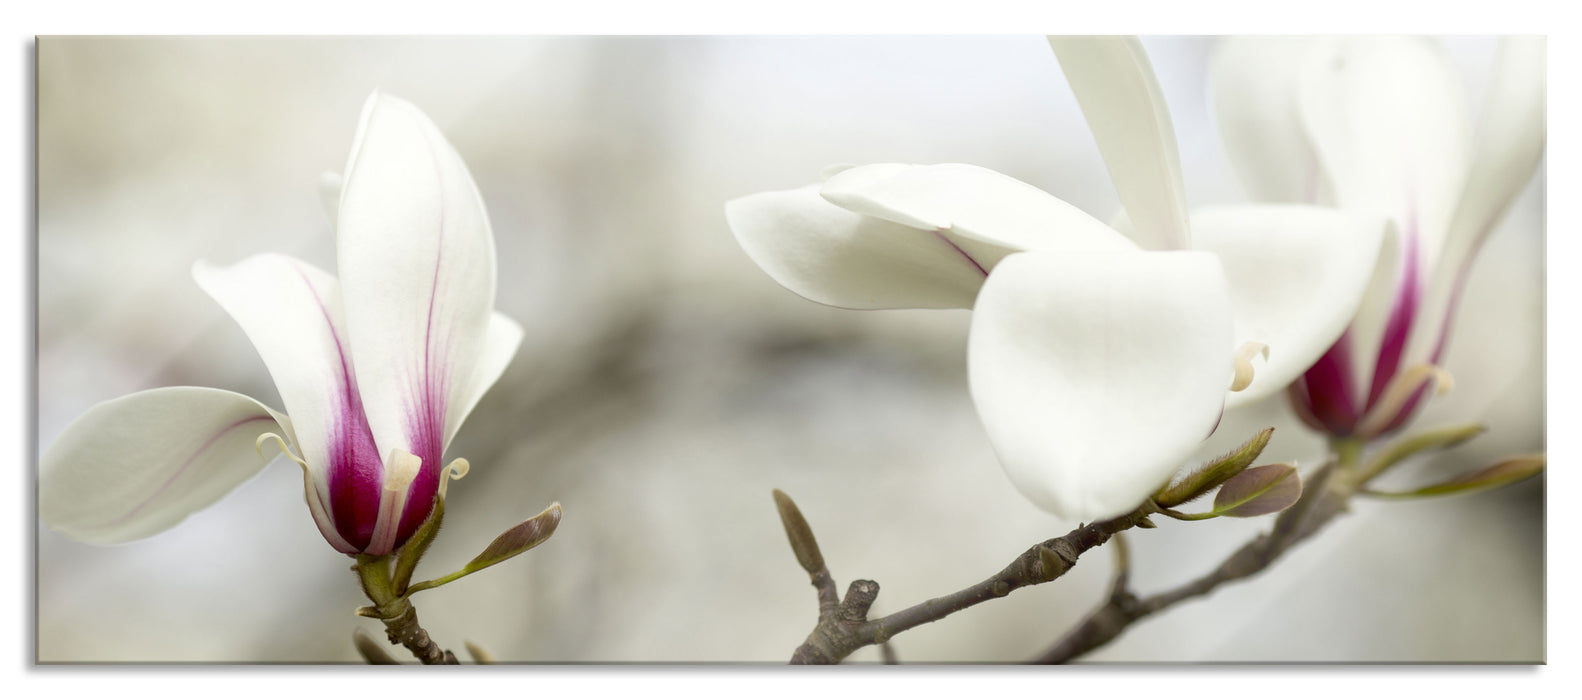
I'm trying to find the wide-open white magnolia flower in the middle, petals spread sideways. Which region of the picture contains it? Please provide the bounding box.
[726,38,1383,519]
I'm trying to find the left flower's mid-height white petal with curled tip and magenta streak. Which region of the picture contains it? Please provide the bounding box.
[193,253,363,494]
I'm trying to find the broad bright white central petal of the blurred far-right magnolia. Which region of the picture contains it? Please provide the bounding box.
[1300,36,1470,275]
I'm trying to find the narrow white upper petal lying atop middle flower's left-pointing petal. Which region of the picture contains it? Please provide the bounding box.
[819,163,1136,254]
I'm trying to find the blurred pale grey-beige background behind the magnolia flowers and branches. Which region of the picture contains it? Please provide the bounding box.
[36,36,1544,662]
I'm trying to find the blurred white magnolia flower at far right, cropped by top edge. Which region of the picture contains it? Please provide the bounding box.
[1213,36,1546,437]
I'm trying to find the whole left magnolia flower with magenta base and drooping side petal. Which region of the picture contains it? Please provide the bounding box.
[40,93,522,554]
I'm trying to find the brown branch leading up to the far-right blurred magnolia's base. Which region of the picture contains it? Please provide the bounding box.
[1035,462,1356,664]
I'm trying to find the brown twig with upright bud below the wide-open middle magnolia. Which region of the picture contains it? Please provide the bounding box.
[775,491,1152,664]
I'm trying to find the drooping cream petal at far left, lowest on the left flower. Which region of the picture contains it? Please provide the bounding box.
[38,386,286,545]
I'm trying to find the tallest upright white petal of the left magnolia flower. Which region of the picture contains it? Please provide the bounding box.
[337,93,495,465]
